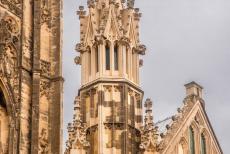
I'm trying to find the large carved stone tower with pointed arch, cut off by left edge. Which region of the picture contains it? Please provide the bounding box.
[0,0,63,154]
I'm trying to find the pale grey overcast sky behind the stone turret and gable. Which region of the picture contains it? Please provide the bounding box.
[63,0,230,154]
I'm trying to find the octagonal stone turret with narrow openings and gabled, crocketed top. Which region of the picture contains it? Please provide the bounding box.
[66,0,146,154]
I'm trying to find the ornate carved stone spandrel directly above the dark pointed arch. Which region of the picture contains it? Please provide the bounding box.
[0,15,20,102]
